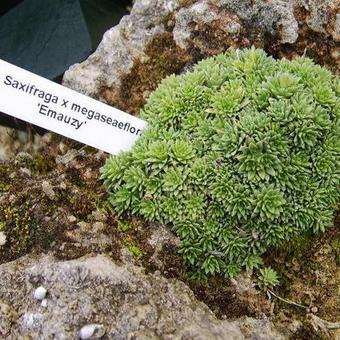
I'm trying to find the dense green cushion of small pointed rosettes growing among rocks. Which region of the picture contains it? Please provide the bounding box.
[102,49,340,282]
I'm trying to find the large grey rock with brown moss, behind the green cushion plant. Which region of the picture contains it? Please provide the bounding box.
[63,0,340,112]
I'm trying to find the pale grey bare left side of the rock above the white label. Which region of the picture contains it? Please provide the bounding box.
[63,0,178,96]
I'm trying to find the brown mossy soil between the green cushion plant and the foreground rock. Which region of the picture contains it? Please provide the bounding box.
[0,131,340,339]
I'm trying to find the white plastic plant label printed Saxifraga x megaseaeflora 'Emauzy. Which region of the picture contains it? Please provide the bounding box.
[0,59,146,154]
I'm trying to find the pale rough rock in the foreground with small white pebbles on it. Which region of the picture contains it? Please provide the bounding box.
[0,255,282,339]
